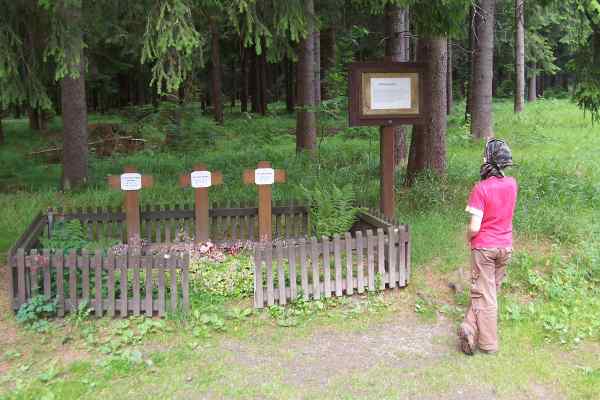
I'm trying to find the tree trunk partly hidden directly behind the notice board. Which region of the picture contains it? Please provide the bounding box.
[386,4,410,167]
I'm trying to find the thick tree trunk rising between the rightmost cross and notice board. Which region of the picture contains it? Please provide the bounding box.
[296,0,317,152]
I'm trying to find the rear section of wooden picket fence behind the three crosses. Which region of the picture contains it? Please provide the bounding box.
[42,204,309,243]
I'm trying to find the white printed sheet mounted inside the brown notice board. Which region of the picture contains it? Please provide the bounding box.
[371,78,411,110]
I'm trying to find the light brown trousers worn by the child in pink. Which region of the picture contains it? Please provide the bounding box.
[464,248,512,352]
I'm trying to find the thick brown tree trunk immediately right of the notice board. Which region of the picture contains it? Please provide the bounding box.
[406,38,448,186]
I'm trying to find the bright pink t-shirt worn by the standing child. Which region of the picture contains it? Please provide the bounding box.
[466,176,518,249]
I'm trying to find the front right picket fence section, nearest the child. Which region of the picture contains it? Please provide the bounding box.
[254,225,410,308]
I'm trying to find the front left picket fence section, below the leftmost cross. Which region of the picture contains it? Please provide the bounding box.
[8,248,190,317]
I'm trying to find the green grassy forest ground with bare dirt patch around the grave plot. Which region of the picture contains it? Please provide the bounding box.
[0,100,600,400]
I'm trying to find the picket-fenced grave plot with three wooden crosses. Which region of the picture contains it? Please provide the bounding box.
[8,162,410,317]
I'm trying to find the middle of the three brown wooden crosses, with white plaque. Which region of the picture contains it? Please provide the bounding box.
[179,163,223,243]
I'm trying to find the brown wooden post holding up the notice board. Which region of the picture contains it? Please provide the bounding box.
[379,126,396,218]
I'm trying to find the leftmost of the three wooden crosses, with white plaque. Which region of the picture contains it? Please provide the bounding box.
[108,166,154,244]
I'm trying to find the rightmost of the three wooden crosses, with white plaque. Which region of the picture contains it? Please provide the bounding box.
[244,161,285,241]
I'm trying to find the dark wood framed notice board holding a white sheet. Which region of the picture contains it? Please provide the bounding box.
[348,62,425,126]
